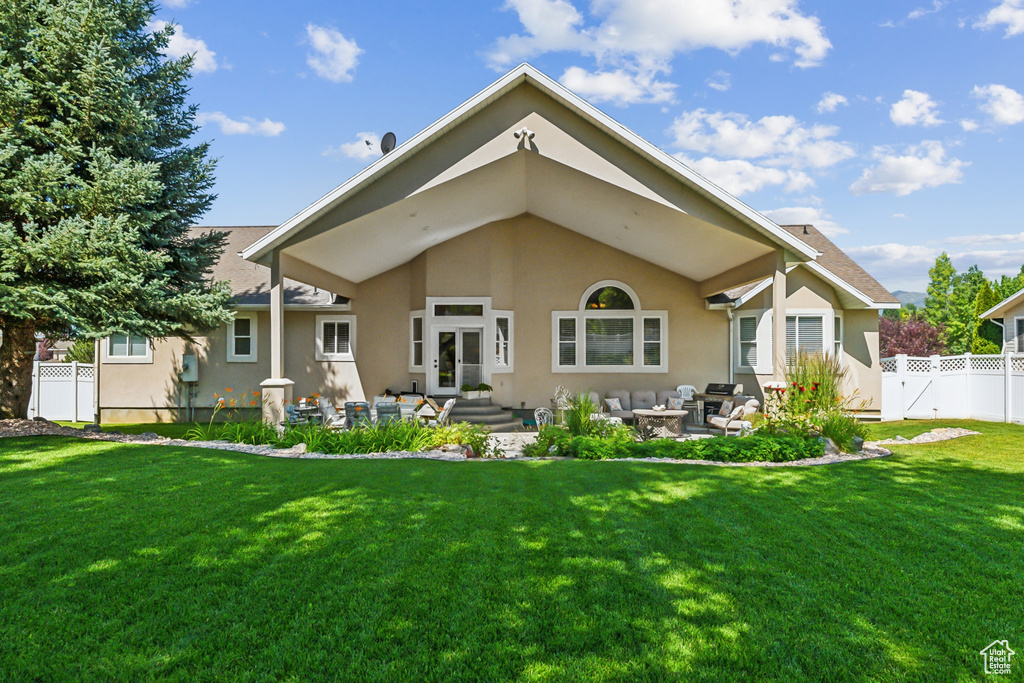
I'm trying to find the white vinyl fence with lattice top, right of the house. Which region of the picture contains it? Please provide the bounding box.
[882,353,1024,424]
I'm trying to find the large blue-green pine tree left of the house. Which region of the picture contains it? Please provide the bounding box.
[0,0,228,418]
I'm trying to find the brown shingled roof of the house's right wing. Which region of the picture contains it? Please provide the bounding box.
[713,224,900,308]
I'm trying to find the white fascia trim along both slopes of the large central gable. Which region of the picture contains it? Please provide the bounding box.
[242,63,817,261]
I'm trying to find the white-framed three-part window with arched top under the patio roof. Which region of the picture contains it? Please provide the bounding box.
[551,281,668,373]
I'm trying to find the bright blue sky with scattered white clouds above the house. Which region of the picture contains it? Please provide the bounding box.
[156,0,1024,291]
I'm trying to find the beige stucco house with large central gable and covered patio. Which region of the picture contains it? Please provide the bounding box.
[99,65,899,422]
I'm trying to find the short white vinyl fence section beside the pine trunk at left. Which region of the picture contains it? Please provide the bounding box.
[29,360,96,422]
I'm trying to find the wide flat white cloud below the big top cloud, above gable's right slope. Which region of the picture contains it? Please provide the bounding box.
[672,109,854,168]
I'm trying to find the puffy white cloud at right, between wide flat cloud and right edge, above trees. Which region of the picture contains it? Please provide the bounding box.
[850,140,970,197]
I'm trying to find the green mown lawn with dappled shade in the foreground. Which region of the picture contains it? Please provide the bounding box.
[0,423,1024,681]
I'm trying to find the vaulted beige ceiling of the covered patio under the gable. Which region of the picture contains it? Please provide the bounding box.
[283,150,777,283]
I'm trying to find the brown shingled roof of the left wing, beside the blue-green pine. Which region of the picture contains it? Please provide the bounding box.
[190,225,347,307]
